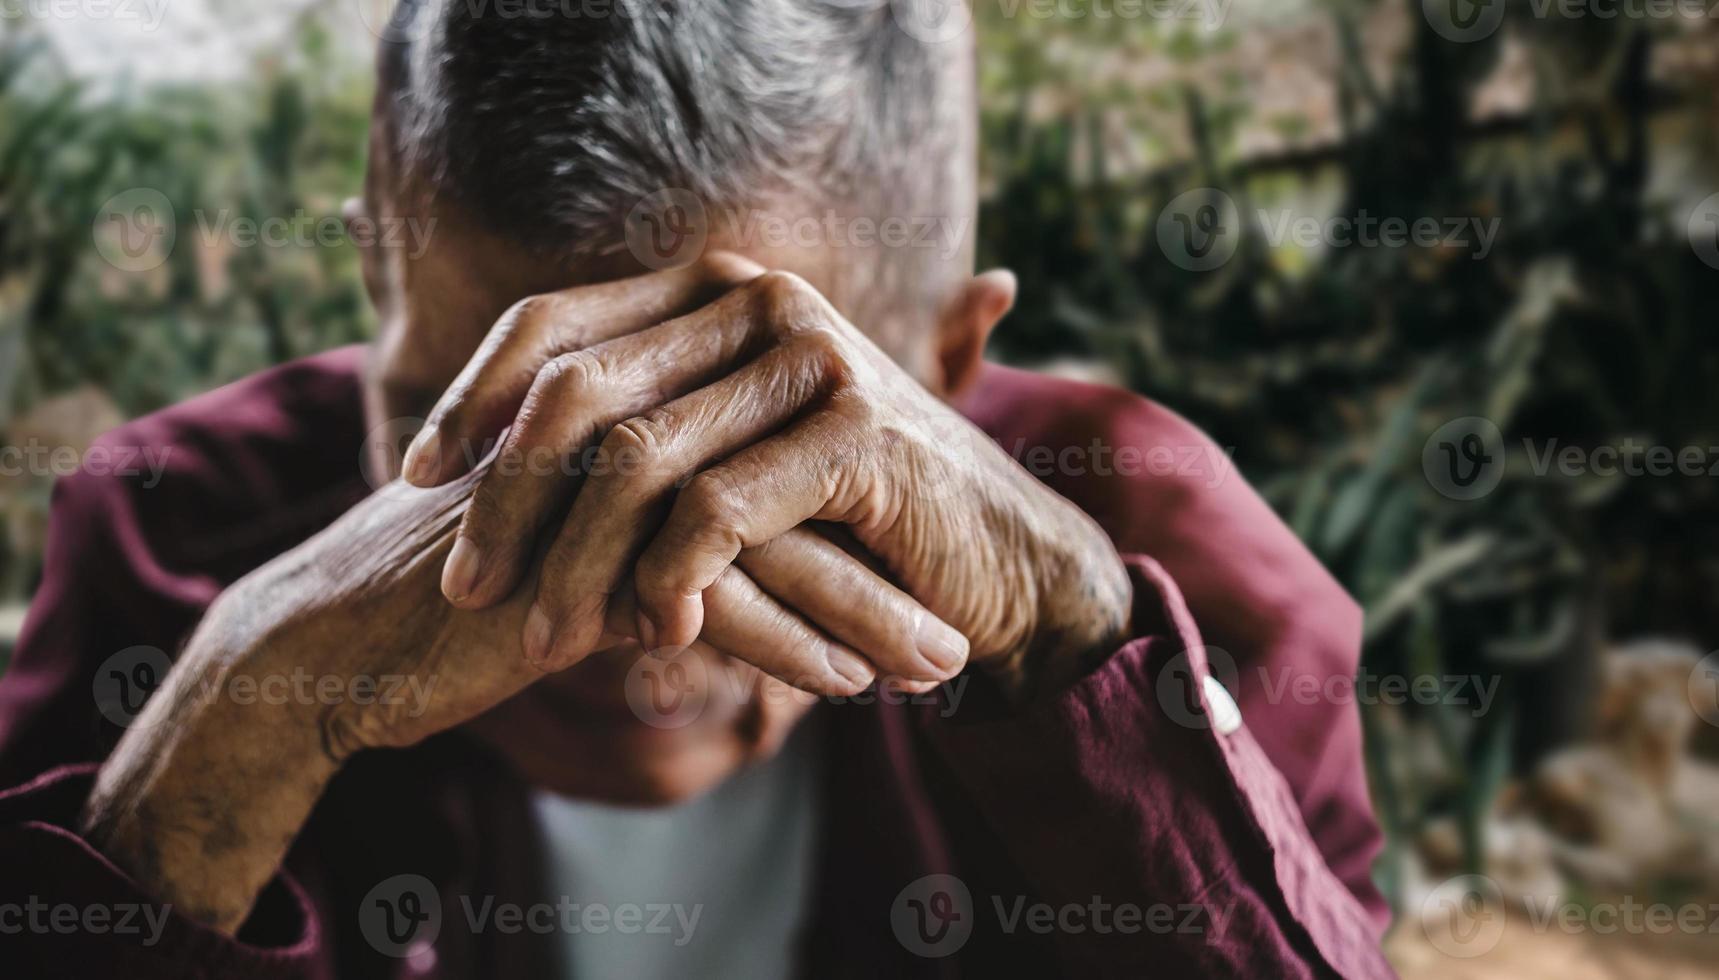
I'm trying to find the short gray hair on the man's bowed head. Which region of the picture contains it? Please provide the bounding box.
[382,0,973,266]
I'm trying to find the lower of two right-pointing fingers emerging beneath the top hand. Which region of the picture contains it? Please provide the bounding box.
[698,566,877,696]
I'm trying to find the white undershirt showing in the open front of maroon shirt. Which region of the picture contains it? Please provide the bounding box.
[533,724,818,980]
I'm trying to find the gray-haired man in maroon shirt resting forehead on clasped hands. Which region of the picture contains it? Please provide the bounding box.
[0,0,1389,978]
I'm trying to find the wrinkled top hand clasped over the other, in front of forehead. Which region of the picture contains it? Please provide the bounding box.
[406,256,1129,693]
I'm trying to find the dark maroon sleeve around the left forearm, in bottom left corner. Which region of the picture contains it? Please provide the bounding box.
[0,765,332,980]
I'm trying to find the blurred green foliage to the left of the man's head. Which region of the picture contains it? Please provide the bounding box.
[0,22,373,605]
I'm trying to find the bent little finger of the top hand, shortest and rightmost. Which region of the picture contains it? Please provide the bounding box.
[632,399,866,645]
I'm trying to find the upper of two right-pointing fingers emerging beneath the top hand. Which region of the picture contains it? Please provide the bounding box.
[732,526,968,684]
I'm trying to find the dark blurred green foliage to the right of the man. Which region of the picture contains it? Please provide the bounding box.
[980,0,1719,896]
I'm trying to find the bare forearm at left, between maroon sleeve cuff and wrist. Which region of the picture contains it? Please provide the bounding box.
[83,594,339,935]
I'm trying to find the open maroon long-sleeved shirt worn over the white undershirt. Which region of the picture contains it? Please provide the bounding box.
[0,347,1391,978]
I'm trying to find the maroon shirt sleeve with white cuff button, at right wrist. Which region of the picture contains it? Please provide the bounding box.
[918,555,1392,977]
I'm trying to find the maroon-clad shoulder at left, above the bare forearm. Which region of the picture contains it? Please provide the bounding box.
[0,349,368,782]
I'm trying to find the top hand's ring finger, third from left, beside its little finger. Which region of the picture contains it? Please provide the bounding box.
[526,287,834,667]
